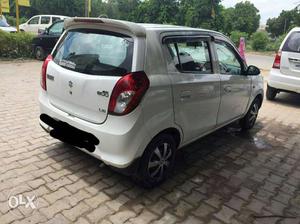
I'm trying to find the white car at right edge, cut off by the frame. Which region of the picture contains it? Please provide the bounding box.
[266,27,300,100]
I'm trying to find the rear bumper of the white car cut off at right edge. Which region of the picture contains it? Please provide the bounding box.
[268,69,300,93]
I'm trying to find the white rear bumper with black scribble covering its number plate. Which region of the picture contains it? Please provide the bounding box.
[39,91,148,169]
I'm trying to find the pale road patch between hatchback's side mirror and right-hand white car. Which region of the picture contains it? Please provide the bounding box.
[246,53,274,70]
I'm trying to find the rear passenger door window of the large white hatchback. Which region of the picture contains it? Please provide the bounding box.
[168,39,212,74]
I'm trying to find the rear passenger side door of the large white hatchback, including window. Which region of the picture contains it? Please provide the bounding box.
[166,37,220,141]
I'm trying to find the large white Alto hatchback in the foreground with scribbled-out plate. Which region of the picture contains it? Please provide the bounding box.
[39,18,263,187]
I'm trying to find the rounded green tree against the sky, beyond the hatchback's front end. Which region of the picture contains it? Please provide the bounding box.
[222,1,260,35]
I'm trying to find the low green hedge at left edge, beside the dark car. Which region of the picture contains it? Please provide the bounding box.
[0,30,33,58]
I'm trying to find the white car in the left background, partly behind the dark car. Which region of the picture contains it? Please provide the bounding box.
[20,15,69,34]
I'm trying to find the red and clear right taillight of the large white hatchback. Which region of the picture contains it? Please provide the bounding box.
[108,72,149,115]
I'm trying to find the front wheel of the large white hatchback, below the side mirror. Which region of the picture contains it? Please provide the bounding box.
[240,98,261,131]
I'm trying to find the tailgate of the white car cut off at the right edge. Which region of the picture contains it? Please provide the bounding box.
[280,31,300,78]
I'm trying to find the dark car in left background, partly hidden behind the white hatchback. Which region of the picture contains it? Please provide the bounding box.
[32,20,64,60]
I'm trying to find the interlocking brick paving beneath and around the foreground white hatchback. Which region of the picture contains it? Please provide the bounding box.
[0,62,300,224]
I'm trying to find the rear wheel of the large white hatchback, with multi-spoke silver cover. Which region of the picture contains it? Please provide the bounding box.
[134,134,176,188]
